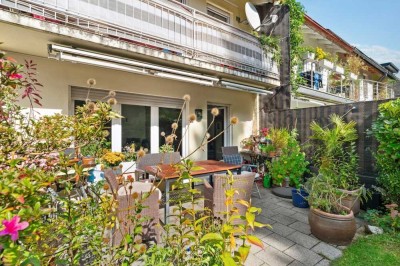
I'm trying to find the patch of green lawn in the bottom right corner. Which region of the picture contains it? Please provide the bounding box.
[332,234,400,266]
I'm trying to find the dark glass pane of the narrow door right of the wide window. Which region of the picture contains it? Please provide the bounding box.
[207,105,225,161]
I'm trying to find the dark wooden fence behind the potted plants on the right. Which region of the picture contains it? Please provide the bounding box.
[260,101,390,177]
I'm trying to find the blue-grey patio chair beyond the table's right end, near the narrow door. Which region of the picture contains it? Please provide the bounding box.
[222,146,261,199]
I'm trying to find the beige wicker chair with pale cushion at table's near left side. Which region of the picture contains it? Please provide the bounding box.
[113,182,161,245]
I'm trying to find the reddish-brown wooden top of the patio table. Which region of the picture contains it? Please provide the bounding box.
[145,160,242,179]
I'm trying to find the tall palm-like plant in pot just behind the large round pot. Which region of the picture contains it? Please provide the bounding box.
[310,114,367,214]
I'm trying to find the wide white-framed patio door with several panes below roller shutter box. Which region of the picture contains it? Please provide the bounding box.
[71,87,188,155]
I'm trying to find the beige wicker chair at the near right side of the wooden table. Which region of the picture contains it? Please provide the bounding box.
[204,173,255,223]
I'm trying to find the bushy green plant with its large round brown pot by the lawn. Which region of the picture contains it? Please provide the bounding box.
[306,172,356,245]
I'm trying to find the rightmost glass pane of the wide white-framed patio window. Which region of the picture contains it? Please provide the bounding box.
[159,107,182,154]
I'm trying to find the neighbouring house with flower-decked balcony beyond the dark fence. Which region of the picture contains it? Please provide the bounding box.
[291,15,399,108]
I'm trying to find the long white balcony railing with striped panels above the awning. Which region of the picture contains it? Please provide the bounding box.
[0,0,279,78]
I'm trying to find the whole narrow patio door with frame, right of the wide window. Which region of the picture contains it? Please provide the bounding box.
[207,104,230,161]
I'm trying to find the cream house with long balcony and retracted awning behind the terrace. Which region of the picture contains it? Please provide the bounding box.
[0,0,280,160]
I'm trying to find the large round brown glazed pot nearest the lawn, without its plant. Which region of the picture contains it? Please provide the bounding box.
[308,207,356,246]
